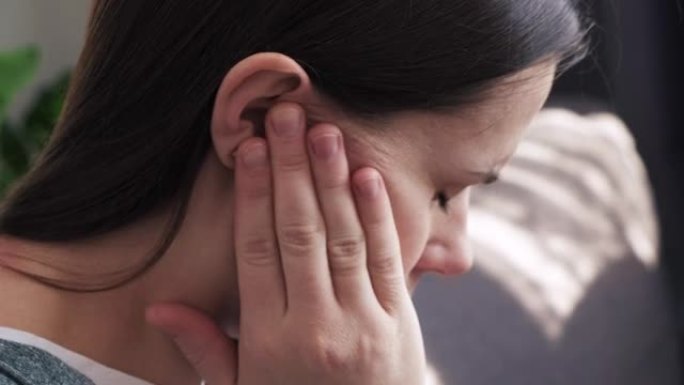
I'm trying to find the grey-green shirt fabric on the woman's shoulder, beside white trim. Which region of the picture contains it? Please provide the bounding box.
[0,340,95,385]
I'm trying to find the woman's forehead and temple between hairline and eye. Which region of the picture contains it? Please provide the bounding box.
[356,65,555,182]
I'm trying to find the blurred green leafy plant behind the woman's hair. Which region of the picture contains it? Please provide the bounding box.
[0,46,70,197]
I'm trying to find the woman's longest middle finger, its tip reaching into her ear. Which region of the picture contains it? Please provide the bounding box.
[266,104,334,308]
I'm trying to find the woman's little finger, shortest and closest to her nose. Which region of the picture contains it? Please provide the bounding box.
[352,168,407,311]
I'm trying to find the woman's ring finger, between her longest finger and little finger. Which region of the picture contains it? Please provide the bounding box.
[309,124,374,304]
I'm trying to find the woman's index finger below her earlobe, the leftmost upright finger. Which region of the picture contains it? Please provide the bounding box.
[234,138,287,322]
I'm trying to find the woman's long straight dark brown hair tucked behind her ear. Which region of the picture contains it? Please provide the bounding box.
[0,0,585,288]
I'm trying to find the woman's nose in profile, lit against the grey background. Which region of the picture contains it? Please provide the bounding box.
[415,191,473,276]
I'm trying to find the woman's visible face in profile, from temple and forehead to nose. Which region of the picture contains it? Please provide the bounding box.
[308,64,555,290]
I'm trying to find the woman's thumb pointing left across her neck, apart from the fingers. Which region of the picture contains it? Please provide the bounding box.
[145,304,238,385]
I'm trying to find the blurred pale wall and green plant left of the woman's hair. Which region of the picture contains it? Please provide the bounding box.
[0,0,90,192]
